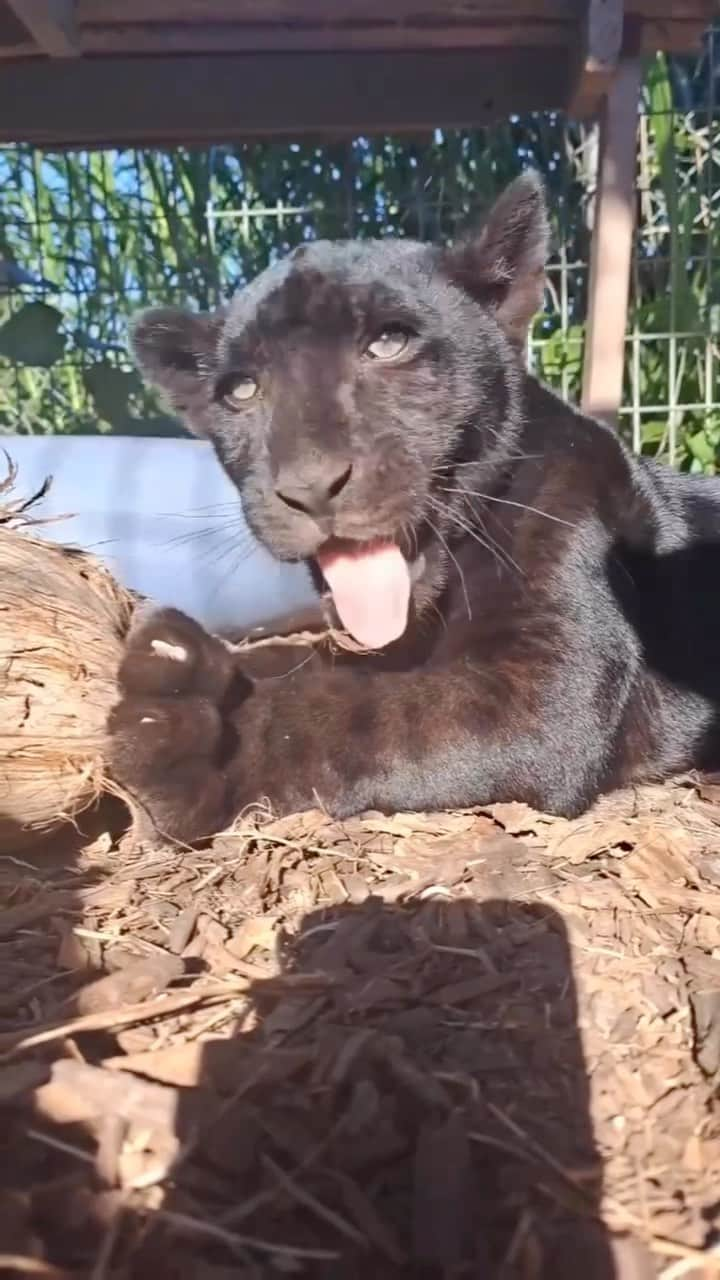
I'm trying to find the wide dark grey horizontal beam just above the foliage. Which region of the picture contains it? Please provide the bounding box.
[0,49,569,147]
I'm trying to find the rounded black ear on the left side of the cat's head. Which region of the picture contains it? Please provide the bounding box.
[131,307,224,425]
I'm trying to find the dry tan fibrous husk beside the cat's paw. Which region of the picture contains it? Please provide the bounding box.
[0,463,133,850]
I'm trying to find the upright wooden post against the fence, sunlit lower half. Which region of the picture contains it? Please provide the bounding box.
[582,58,641,422]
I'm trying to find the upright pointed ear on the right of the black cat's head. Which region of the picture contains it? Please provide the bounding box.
[443,173,550,347]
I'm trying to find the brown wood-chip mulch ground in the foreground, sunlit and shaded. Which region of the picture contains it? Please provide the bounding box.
[0,778,720,1280]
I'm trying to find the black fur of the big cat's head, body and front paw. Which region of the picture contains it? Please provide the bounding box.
[110,178,720,840]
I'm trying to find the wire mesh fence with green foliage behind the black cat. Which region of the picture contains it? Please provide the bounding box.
[0,27,720,470]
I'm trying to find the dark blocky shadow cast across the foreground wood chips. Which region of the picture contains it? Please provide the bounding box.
[0,896,617,1280]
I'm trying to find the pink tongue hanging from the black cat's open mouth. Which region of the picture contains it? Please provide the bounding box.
[318,543,410,649]
